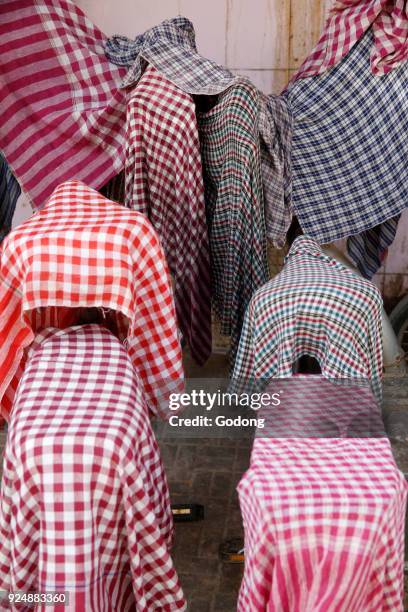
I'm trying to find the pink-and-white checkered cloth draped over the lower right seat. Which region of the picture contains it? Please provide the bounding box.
[238,377,407,612]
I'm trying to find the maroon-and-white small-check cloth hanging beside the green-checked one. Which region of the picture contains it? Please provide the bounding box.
[126,66,211,364]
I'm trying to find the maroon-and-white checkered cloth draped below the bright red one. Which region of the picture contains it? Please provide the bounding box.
[0,325,185,612]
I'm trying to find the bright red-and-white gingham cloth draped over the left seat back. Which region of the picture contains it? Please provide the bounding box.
[0,181,183,418]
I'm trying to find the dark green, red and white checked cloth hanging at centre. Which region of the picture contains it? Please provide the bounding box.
[198,79,268,360]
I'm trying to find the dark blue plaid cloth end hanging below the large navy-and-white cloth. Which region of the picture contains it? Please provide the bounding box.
[347,215,401,278]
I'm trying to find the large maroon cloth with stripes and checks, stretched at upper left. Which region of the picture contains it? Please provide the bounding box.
[0,0,126,208]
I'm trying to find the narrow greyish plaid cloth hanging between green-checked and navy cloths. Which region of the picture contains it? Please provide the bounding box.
[259,95,293,249]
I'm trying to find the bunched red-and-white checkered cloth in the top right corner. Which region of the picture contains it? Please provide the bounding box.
[292,0,408,81]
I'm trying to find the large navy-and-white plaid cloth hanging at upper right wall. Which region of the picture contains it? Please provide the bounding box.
[285,30,408,252]
